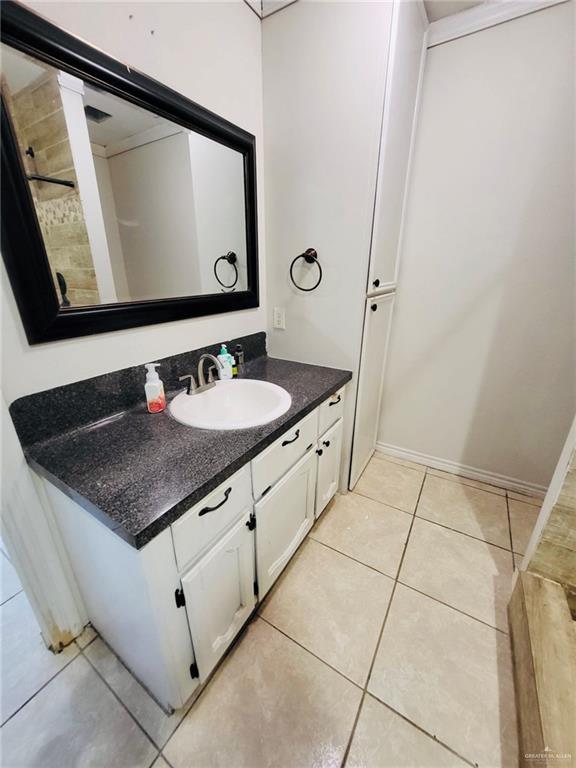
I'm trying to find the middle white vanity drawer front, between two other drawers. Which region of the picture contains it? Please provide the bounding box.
[252,409,318,499]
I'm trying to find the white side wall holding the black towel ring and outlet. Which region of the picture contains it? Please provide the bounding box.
[262,2,392,480]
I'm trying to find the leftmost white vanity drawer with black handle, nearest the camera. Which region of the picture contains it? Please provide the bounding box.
[171,465,252,571]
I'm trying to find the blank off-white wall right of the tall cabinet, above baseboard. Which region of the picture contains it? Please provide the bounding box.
[379,3,576,485]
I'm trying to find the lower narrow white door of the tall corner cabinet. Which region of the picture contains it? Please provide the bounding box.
[350,293,395,488]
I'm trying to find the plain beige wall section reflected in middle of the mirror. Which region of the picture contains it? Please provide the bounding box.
[108,132,201,300]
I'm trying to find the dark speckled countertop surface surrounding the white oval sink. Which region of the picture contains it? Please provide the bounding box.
[24,356,352,549]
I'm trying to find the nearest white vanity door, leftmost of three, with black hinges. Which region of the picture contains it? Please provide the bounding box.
[182,514,256,682]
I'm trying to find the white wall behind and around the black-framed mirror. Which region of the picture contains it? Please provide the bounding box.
[2,1,266,403]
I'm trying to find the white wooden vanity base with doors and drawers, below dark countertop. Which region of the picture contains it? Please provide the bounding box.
[45,389,344,710]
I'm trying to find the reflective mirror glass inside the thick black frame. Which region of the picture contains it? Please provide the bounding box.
[2,44,247,310]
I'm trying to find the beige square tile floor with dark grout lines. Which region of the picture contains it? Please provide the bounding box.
[0,456,539,768]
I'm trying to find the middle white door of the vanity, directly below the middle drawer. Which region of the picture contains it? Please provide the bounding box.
[254,448,317,599]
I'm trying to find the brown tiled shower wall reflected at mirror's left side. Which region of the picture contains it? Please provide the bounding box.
[3,68,99,306]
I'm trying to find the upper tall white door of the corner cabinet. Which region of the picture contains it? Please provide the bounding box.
[368,2,427,293]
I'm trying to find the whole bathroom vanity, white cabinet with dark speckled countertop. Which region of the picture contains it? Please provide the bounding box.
[12,334,350,709]
